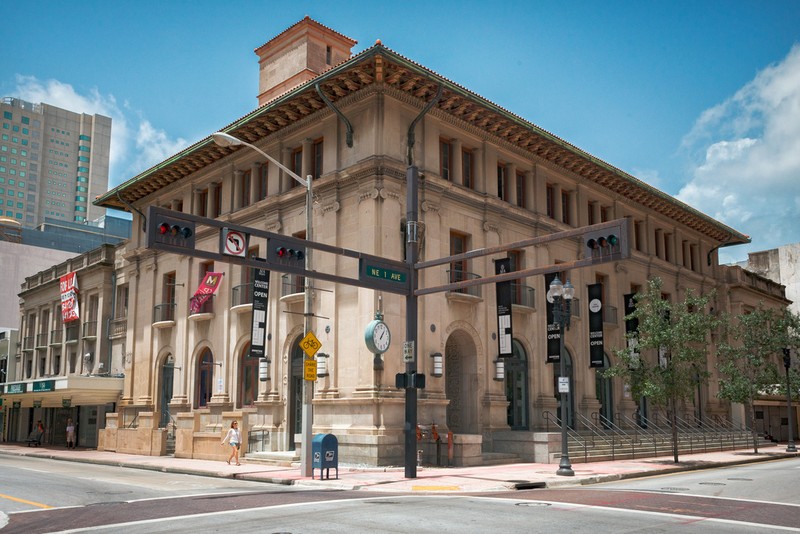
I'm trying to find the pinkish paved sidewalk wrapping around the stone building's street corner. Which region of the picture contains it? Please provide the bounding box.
[0,443,798,493]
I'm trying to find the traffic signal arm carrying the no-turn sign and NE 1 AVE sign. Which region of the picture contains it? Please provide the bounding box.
[145,206,410,295]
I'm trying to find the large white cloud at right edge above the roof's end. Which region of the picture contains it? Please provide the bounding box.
[678,45,800,261]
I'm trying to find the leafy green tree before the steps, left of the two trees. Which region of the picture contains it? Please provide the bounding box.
[606,278,718,463]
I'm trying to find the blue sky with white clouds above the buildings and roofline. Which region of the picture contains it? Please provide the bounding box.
[0,0,800,263]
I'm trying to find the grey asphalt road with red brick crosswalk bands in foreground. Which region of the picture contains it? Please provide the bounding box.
[0,457,800,534]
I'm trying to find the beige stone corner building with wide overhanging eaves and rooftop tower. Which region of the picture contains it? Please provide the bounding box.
[90,18,785,465]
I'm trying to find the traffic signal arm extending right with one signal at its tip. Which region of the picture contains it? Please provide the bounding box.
[414,219,630,296]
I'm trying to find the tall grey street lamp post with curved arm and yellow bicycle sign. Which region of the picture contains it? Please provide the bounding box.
[211,132,314,477]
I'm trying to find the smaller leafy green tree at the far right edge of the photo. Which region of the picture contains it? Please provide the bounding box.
[717,304,800,453]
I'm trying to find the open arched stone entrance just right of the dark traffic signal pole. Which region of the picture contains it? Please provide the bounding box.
[444,330,478,434]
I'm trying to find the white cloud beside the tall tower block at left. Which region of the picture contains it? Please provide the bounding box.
[16,75,188,188]
